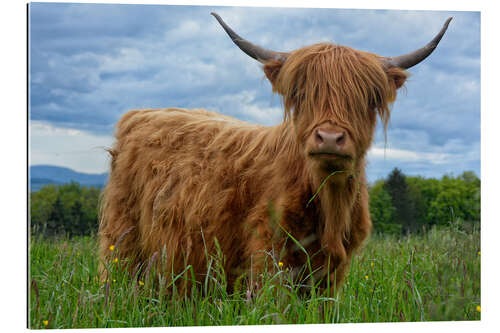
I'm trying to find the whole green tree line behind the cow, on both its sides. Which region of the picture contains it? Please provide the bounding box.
[30,168,481,237]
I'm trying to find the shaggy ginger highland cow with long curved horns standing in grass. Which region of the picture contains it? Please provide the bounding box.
[99,13,451,287]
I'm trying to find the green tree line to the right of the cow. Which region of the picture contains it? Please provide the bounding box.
[369,168,481,234]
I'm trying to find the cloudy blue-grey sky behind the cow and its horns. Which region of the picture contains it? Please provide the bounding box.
[28,3,481,181]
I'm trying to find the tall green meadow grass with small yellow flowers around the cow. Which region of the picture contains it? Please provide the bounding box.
[29,224,480,328]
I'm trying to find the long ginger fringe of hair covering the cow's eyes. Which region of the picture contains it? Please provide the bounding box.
[273,43,408,149]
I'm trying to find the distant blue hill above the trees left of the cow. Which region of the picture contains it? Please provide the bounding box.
[30,165,108,191]
